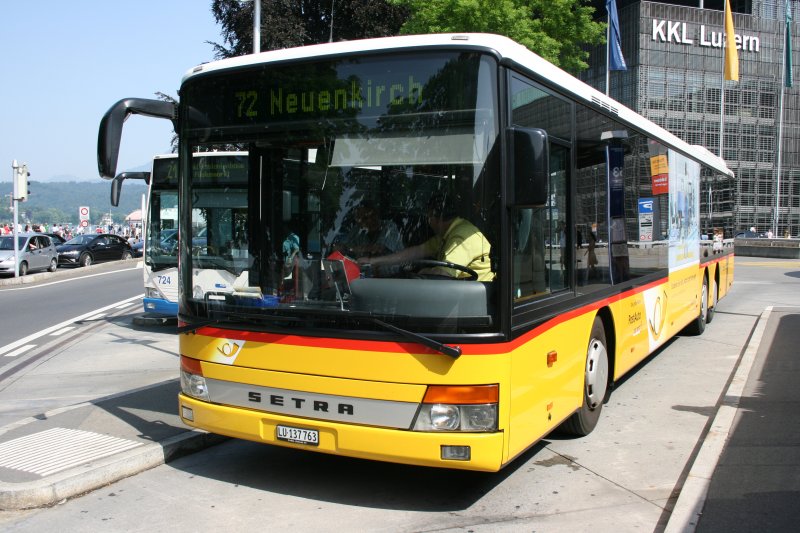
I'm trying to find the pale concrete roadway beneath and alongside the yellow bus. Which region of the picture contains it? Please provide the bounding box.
[0,258,800,532]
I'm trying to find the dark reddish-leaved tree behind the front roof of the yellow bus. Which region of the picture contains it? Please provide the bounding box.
[210,0,407,59]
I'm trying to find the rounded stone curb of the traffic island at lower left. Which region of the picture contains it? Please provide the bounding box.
[0,430,227,511]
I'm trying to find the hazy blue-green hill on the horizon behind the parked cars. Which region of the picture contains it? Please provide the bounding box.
[0,179,147,225]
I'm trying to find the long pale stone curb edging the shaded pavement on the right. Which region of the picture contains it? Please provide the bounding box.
[664,306,772,533]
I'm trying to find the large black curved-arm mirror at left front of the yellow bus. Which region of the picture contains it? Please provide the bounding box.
[97,98,178,179]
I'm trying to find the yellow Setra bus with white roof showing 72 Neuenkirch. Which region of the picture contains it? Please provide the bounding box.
[98,34,733,471]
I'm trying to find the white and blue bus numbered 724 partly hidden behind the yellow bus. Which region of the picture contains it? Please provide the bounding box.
[111,152,247,317]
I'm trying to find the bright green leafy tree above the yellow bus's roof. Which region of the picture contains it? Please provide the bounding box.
[393,0,606,73]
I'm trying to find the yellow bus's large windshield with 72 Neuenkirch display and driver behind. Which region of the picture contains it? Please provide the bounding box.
[180,51,500,333]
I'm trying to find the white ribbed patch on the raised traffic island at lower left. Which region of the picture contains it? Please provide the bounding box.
[0,428,144,477]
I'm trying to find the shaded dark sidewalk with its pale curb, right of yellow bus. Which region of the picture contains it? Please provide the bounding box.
[665,308,800,533]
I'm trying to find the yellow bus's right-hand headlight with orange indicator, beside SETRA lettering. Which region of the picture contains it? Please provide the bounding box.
[413,385,498,432]
